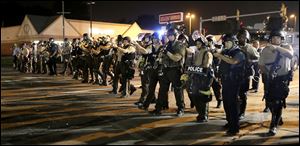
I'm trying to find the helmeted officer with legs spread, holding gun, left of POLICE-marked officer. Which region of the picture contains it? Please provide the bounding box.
[150,28,185,116]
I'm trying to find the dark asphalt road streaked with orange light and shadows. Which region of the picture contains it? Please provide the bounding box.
[1,67,299,145]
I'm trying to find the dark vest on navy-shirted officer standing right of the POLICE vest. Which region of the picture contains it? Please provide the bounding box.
[219,47,246,81]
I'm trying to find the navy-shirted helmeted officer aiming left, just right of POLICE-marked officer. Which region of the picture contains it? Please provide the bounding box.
[213,34,246,135]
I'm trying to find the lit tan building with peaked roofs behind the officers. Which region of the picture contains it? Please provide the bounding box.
[1,15,154,56]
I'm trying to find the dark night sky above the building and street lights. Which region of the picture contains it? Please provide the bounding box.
[1,1,299,33]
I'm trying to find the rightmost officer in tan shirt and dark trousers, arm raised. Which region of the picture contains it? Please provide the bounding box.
[258,30,294,135]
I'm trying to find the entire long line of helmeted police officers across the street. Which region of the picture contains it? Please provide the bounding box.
[14,24,293,135]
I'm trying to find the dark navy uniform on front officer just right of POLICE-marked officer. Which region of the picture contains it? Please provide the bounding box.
[220,46,246,133]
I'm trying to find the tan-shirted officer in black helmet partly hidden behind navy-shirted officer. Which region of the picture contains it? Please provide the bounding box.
[237,29,259,119]
